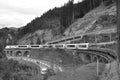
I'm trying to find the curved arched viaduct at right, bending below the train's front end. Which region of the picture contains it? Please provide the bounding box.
[76,49,116,63]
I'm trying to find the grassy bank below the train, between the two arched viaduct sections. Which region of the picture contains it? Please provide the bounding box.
[31,49,83,66]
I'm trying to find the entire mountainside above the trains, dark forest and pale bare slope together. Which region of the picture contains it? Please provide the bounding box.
[1,0,116,44]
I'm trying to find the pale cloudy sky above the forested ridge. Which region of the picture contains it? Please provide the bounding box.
[0,0,81,28]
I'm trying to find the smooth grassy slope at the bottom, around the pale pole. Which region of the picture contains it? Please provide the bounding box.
[48,63,105,80]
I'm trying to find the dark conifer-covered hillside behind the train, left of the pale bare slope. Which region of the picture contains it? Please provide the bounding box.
[17,0,115,44]
